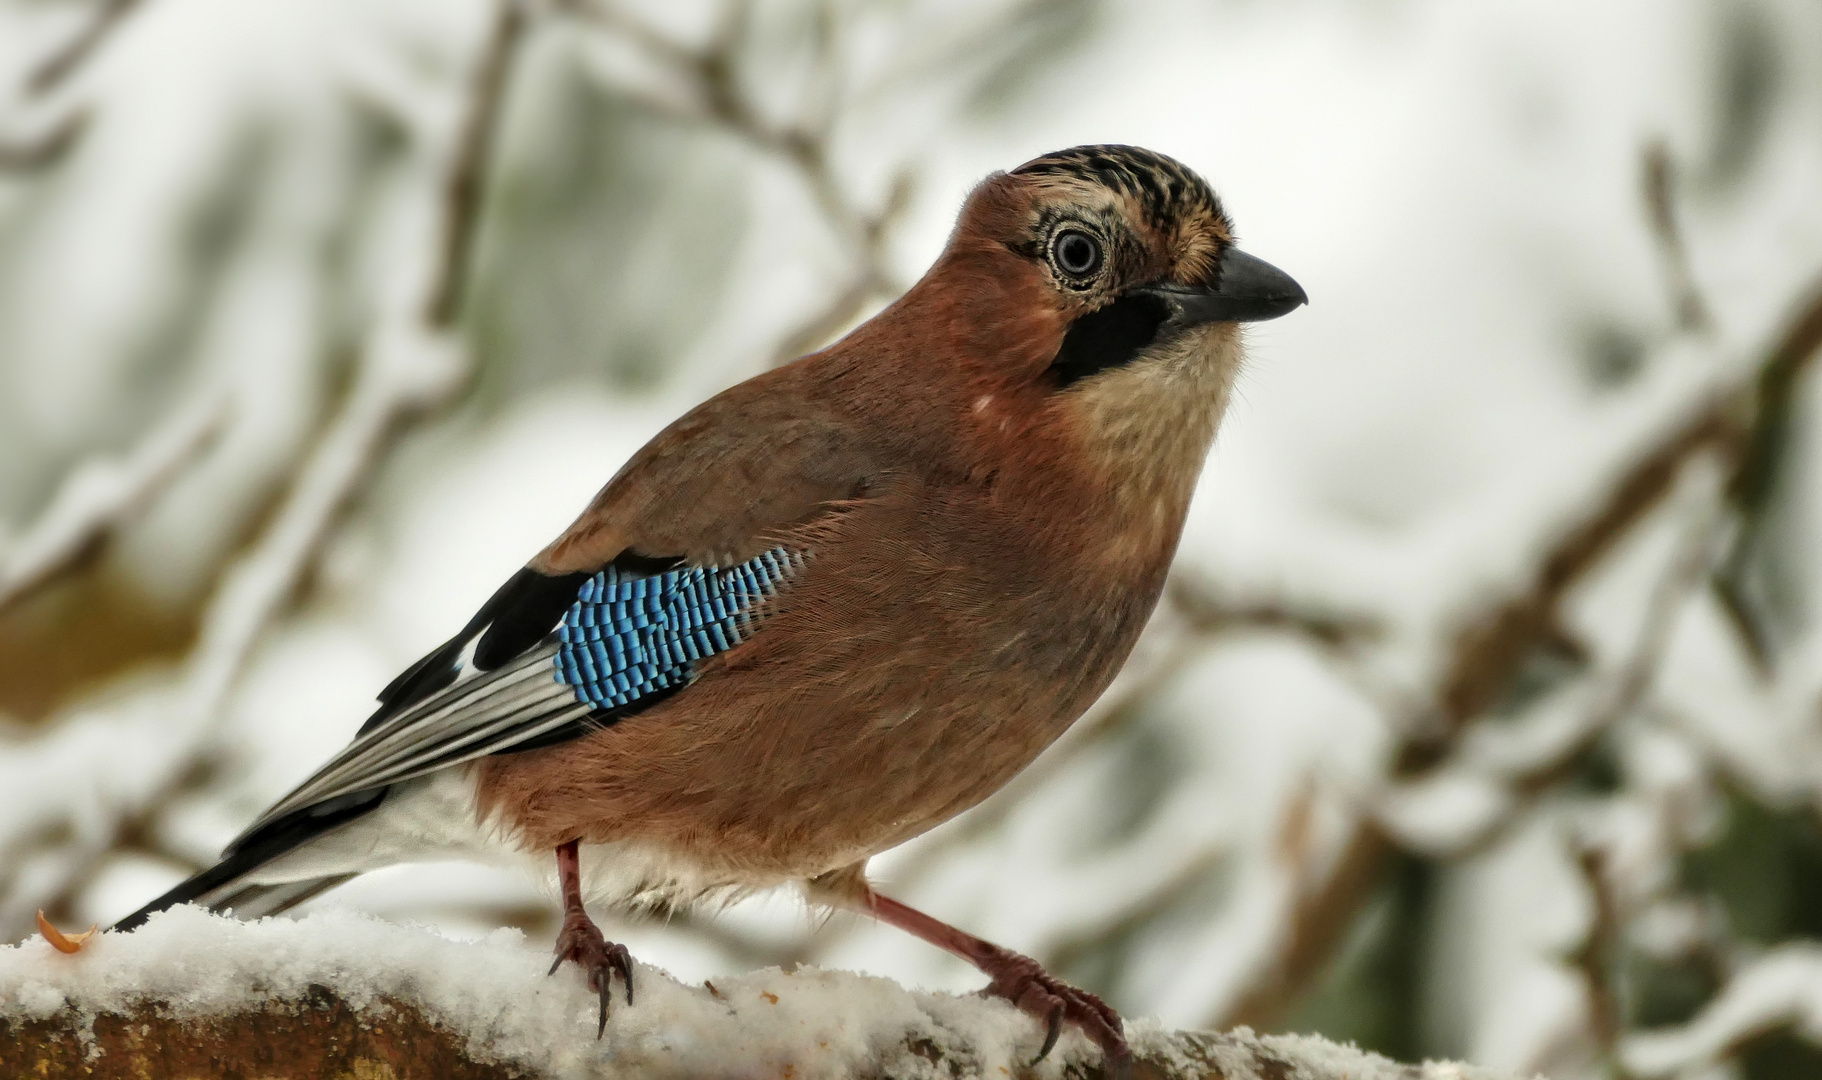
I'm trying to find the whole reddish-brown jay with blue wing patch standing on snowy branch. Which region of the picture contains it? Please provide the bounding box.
[115,144,1308,1062]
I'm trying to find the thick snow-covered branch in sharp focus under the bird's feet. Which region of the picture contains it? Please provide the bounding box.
[0,909,1523,1080]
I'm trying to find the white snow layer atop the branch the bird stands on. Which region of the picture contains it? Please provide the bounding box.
[0,907,1523,1080]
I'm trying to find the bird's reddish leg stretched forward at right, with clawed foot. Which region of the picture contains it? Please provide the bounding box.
[862,889,1131,1069]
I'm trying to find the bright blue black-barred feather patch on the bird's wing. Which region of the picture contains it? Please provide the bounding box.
[556,546,809,708]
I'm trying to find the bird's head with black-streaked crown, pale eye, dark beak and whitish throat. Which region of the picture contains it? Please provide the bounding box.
[892,146,1306,524]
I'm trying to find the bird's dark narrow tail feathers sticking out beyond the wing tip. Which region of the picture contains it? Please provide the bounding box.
[113,787,386,931]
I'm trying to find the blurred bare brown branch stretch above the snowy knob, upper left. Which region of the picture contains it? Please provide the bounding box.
[425,0,528,330]
